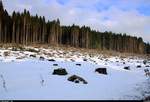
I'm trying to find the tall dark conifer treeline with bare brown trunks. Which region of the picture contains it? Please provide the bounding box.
[0,1,150,54]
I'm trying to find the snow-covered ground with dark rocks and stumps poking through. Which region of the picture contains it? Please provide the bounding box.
[0,47,150,100]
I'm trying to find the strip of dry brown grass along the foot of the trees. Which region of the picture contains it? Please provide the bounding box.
[0,44,150,59]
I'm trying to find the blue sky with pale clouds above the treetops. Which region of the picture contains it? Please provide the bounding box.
[3,0,150,42]
